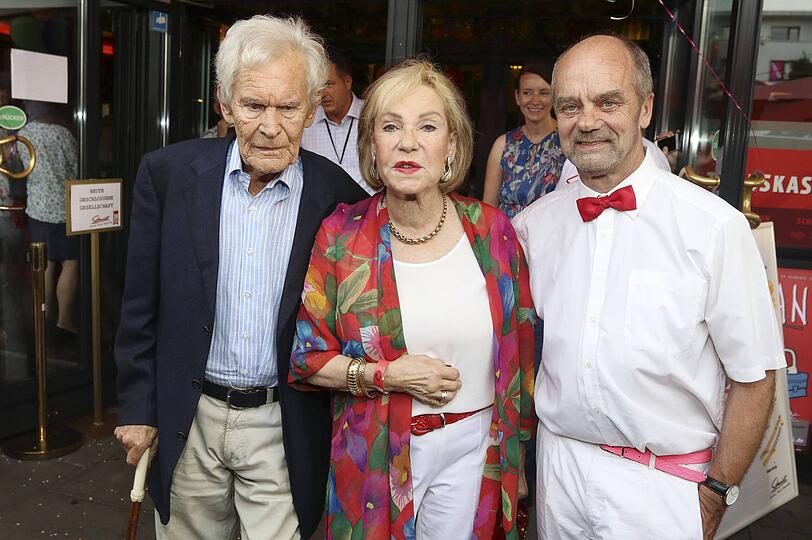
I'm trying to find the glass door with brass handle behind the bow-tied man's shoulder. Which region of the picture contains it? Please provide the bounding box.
[666,0,761,208]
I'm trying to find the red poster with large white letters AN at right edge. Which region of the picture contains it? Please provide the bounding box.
[778,268,812,450]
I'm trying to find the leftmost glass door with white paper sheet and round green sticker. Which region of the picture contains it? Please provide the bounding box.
[0,0,87,437]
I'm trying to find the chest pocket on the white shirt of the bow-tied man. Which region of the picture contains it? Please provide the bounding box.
[623,270,707,356]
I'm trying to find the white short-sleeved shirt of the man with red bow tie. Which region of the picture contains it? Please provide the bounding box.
[513,152,785,455]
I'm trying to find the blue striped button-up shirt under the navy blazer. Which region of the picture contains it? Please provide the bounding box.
[206,141,304,388]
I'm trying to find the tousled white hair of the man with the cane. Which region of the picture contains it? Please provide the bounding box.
[214,15,329,107]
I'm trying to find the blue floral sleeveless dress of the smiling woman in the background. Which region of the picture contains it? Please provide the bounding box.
[499,127,567,219]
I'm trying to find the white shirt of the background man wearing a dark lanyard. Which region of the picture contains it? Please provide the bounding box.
[302,94,375,195]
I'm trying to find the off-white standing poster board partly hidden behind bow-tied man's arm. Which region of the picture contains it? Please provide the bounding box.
[716,223,798,538]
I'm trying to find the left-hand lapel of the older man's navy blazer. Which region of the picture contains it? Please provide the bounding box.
[184,136,234,320]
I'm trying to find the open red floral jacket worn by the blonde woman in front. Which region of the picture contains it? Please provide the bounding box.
[290,194,535,540]
